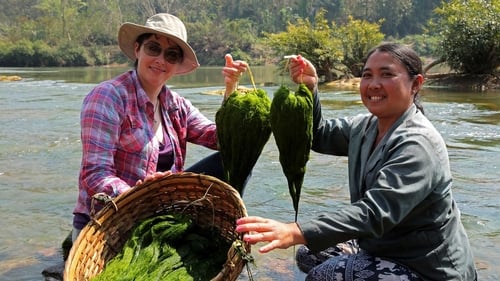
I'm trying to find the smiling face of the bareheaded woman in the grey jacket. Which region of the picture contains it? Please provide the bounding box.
[360,51,423,122]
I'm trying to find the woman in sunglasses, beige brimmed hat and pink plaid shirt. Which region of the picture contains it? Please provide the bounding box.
[73,14,247,241]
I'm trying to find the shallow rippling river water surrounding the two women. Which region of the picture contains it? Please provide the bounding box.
[0,68,500,281]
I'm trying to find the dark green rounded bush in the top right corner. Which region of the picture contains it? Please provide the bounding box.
[430,0,500,74]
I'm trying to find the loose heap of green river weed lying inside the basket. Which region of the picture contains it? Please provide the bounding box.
[92,214,231,281]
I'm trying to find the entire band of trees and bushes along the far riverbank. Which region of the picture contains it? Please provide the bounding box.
[0,0,500,77]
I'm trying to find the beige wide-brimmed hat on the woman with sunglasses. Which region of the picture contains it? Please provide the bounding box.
[118,13,200,74]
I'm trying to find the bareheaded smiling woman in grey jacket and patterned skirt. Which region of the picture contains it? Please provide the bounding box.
[237,43,477,281]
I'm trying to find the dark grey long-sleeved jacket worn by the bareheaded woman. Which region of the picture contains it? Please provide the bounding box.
[299,95,476,281]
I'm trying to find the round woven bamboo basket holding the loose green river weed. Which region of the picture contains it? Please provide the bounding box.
[64,173,250,281]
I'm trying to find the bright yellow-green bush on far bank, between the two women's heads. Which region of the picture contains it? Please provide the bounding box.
[265,10,384,82]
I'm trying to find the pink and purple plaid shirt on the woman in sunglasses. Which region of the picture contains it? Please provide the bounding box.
[74,70,217,215]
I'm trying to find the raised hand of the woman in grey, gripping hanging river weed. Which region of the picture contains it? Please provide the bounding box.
[289,55,318,92]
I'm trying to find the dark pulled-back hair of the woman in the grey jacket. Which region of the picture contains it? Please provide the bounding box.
[363,43,424,113]
